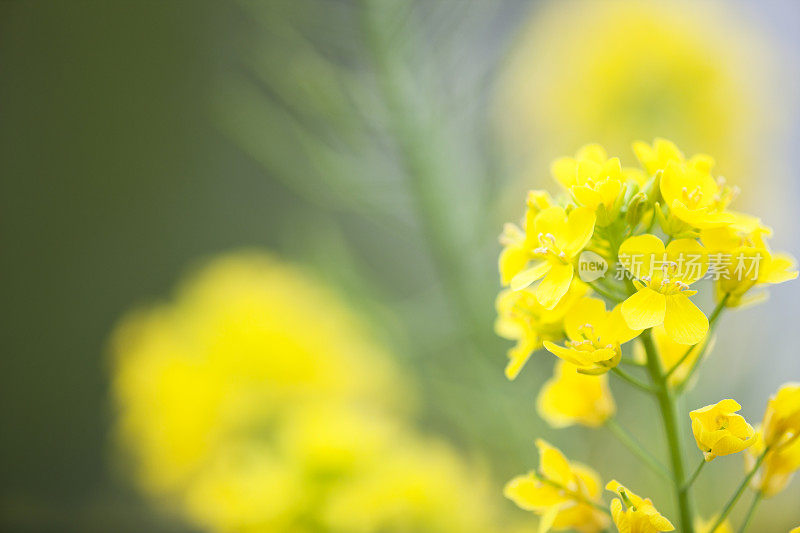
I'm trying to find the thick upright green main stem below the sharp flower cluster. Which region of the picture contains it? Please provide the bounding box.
[639,330,694,533]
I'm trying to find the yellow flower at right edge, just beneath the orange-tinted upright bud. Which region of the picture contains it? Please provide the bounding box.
[744,431,800,497]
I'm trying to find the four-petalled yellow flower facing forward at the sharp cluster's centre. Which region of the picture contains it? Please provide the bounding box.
[619,235,708,345]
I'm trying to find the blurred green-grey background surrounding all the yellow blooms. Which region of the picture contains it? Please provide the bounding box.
[0,0,800,531]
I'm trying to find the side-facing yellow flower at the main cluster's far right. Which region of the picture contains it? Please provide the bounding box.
[700,224,797,307]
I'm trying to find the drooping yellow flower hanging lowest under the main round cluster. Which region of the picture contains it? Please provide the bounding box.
[536,361,616,428]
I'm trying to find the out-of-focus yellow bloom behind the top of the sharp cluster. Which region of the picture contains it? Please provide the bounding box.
[497,0,775,181]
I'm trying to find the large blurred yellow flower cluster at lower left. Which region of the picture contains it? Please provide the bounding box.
[112,252,496,533]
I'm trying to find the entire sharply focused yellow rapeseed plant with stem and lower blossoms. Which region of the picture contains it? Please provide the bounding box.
[496,139,800,533]
